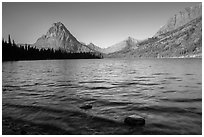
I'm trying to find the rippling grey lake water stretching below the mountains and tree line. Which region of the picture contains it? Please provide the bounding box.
[2,59,202,134]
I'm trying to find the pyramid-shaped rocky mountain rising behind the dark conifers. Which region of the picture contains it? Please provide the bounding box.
[33,22,95,53]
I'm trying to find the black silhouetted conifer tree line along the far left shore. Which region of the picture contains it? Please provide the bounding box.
[2,35,103,61]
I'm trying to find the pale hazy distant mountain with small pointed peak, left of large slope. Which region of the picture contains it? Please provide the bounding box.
[103,37,139,54]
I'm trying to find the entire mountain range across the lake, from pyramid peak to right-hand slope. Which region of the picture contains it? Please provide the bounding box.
[33,4,202,58]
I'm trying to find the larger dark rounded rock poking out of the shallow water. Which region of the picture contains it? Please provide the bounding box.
[124,115,145,126]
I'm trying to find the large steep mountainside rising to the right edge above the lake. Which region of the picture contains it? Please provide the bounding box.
[108,4,202,58]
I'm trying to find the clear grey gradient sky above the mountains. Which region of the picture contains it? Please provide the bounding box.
[2,2,198,48]
